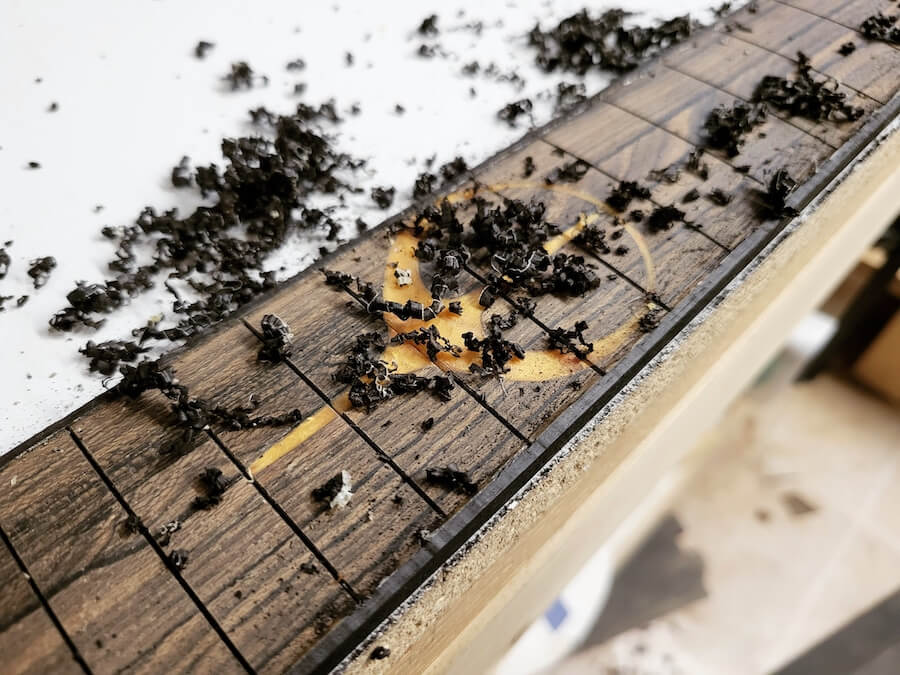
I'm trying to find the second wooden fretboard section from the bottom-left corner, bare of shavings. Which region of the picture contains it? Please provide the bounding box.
[0,432,242,673]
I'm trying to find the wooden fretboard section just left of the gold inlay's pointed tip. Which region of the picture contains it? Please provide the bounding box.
[72,386,352,669]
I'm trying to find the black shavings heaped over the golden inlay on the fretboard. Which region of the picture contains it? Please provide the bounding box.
[323,196,600,402]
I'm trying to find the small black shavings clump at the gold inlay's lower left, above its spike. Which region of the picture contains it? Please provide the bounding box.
[333,329,455,411]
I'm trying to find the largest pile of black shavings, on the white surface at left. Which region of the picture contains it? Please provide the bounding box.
[50,102,363,374]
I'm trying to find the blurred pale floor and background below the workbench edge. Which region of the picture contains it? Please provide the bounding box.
[497,230,900,675]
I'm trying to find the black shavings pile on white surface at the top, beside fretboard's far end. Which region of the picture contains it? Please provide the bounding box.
[528,9,693,75]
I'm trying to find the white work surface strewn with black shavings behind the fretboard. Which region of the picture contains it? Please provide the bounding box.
[0,0,724,454]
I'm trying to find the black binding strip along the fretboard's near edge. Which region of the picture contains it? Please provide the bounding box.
[291,87,900,675]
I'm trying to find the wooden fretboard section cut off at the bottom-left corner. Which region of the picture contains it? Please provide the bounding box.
[0,545,83,675]
